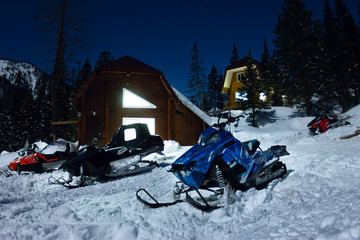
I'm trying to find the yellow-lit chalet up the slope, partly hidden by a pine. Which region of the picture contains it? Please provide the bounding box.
[222,57,261,109]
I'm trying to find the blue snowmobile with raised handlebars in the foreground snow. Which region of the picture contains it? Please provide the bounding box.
[136,116,289,211]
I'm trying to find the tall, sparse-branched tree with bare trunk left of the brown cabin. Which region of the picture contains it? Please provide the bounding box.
[39,0,86,138]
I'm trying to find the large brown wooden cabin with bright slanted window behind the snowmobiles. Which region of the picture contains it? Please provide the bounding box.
[73,56,211,145]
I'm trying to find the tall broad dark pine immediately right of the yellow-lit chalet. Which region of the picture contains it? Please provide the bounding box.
[274,0,319,116]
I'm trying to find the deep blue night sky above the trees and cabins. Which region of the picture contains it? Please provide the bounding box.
[0,0,360,93]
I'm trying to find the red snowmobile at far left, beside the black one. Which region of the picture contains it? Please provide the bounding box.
[2,139,77,176]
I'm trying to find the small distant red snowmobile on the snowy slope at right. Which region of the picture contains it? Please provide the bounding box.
[307,115,350,135]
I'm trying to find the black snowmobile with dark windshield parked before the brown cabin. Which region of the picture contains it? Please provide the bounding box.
[49,123,164,188]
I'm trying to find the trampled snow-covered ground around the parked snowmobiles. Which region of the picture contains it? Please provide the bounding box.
[0,105,360,240]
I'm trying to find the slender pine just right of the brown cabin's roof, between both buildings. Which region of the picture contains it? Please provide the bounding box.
[186,44,206,110]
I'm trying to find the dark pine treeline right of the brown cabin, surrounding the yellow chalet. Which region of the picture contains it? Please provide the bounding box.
[187,0,360,115]
